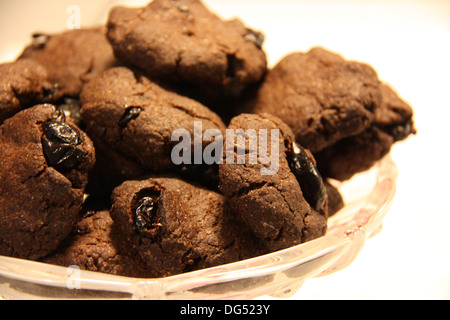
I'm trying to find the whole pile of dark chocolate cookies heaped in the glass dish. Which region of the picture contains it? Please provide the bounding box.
[0,0,415,278]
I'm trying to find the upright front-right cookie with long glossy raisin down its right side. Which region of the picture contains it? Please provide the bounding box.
[219,114,327,250]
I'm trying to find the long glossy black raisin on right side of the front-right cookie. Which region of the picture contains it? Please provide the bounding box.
[289,143,327,211]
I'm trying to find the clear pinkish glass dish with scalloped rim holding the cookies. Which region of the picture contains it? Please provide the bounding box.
[0,155,397,300]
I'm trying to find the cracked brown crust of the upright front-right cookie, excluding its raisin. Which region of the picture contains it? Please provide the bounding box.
[219,114,327,250]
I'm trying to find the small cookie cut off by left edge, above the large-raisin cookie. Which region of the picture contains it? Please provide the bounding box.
[0,59,53,124]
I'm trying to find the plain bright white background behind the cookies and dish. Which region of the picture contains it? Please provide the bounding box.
[0,0,450,300]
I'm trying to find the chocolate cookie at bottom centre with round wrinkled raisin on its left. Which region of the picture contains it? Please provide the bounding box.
[111,177,265,276]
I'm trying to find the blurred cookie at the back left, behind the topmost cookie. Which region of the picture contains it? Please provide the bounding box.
[19,27,118,102]
